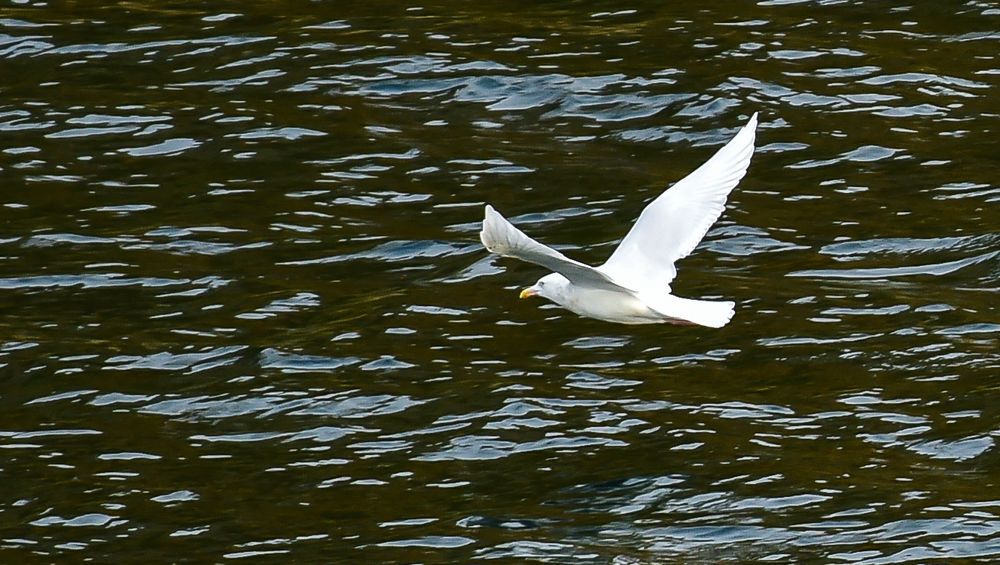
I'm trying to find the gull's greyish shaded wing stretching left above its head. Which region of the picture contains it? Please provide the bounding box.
[479,204,628,292]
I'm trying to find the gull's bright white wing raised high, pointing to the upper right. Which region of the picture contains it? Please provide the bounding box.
[598,113,757,292]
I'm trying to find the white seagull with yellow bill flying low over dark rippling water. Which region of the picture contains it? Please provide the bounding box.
[479,113,757,328]
